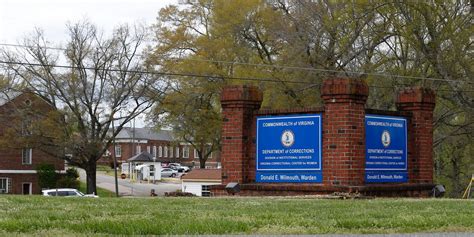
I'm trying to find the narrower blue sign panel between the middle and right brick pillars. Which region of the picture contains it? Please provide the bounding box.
[365,115,408,183]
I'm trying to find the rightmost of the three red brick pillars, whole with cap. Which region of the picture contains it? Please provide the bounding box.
[397,87,436,183]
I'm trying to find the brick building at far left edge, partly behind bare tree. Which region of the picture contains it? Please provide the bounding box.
[0,93,64,194]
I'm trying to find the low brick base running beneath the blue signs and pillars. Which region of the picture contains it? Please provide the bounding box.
[211,183,435,197]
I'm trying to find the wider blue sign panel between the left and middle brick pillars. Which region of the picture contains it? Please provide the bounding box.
[256,114,322,183]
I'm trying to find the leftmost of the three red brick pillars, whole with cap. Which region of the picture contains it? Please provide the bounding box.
[221,85,262,184]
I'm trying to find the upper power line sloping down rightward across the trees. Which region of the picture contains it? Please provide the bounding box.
[0,43,473,84]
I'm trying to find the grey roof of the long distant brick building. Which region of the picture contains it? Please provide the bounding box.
[115,127,174,141]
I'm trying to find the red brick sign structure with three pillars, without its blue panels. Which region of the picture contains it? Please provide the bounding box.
[216,78,435,196]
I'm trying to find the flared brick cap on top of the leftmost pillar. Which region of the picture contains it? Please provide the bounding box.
[221,85,263,107]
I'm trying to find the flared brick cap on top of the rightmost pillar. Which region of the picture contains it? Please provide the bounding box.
[396,86,436,110]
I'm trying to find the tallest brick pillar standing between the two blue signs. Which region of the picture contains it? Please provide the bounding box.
[321,78,369,185]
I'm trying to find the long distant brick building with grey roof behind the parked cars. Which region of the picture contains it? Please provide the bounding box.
[99,127,220,168]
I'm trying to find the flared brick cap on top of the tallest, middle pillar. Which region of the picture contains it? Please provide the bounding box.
[321,78,369,103]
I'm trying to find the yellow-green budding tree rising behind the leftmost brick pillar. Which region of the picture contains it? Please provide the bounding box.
[148,0,390,167]
